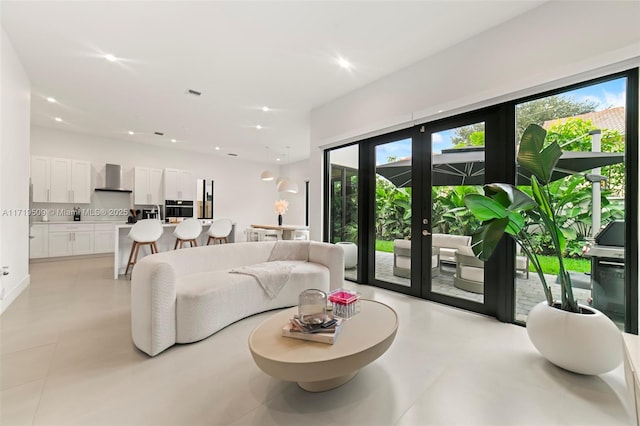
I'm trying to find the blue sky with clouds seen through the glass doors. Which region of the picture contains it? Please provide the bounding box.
[376,78,626,165]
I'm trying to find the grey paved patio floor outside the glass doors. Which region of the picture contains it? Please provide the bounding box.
[345,251,591,322]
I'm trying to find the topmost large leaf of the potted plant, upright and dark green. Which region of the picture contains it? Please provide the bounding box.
[518,124,562,184]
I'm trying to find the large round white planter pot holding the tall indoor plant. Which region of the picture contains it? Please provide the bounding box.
[527,302,622,374]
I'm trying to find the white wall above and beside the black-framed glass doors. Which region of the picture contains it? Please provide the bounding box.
[310,1,640,238]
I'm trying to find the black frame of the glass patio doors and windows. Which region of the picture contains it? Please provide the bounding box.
[324,68,640,334]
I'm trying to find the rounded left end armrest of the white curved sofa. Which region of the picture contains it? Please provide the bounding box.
[131,256,176,356]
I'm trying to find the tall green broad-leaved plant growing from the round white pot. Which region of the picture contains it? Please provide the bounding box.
[465,124,579,312]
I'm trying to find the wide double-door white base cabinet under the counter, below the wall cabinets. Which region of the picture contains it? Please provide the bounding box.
[49,224,94,257]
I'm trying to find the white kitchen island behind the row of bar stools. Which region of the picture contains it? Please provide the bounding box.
[113,219,236,280]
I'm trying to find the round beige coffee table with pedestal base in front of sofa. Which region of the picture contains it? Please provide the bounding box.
[249,300,398,392]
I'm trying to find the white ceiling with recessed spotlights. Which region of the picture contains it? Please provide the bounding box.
[0,0,544,163]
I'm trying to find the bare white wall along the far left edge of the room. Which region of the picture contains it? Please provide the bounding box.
[0,29,31,312]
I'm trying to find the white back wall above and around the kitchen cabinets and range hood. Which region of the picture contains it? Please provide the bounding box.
[31,126,279,241]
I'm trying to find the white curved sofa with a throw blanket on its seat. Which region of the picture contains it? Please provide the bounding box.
[131,241,344,356]
